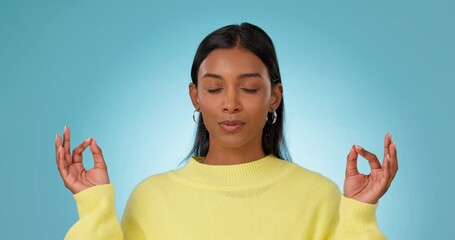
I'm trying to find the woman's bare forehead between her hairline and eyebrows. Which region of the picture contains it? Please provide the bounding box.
[198,47,267,76]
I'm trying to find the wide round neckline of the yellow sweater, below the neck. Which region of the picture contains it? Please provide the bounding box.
[169,155,292,188]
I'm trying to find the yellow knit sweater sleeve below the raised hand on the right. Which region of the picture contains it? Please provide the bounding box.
[333,196,386,240]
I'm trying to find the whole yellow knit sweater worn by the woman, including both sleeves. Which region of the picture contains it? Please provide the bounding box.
[65,155,385,240]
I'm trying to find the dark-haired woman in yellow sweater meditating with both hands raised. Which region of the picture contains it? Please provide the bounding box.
[55,23,398,239]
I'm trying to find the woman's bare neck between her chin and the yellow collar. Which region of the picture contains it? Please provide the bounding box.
[203,142,265,165]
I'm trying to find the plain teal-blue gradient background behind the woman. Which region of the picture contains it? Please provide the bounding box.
[0,0,455,239]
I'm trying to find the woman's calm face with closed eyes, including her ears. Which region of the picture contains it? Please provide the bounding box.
[190,47,282,150]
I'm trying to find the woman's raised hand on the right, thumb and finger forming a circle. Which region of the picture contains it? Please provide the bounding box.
[344,133,398,204]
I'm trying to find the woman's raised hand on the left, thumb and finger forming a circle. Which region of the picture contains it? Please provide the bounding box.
[55,127,109,194]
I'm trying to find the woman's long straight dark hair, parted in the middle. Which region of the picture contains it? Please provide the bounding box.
[188,23,291,161]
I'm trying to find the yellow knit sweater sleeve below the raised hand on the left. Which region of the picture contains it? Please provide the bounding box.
[65,184,123,240]
